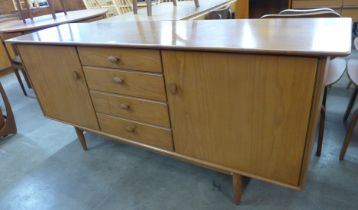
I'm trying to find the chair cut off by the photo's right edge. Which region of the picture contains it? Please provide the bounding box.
[339,38,358,160]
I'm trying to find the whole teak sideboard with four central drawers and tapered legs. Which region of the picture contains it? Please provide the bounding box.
[8,18,352,203]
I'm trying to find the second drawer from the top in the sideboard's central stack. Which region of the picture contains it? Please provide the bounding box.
[83,67,166,101]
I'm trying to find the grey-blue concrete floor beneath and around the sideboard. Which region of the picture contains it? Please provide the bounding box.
[0,53,358,210]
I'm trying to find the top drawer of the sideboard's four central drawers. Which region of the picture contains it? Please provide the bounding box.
[78,47,162,72]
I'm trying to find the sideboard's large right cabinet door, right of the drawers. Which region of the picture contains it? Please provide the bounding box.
[162,51,317,186]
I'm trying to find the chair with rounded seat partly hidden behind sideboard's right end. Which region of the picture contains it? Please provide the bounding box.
[261,8,347,156]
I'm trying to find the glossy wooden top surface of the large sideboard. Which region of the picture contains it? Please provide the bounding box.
[7,18,352,56]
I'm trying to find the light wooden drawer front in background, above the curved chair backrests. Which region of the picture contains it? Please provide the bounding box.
[292,0,342,8]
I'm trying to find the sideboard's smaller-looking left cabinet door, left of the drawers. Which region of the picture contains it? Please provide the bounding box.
[18,45,98,129]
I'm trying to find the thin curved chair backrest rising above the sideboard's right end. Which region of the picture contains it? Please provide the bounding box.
[261,8,341,19]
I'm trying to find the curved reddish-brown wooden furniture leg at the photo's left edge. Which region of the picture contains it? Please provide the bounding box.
[0,82,17,137]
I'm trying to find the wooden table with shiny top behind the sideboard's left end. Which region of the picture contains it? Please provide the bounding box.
[0,9,107,73]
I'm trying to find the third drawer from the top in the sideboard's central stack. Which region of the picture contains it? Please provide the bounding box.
[91,91,170,128]
